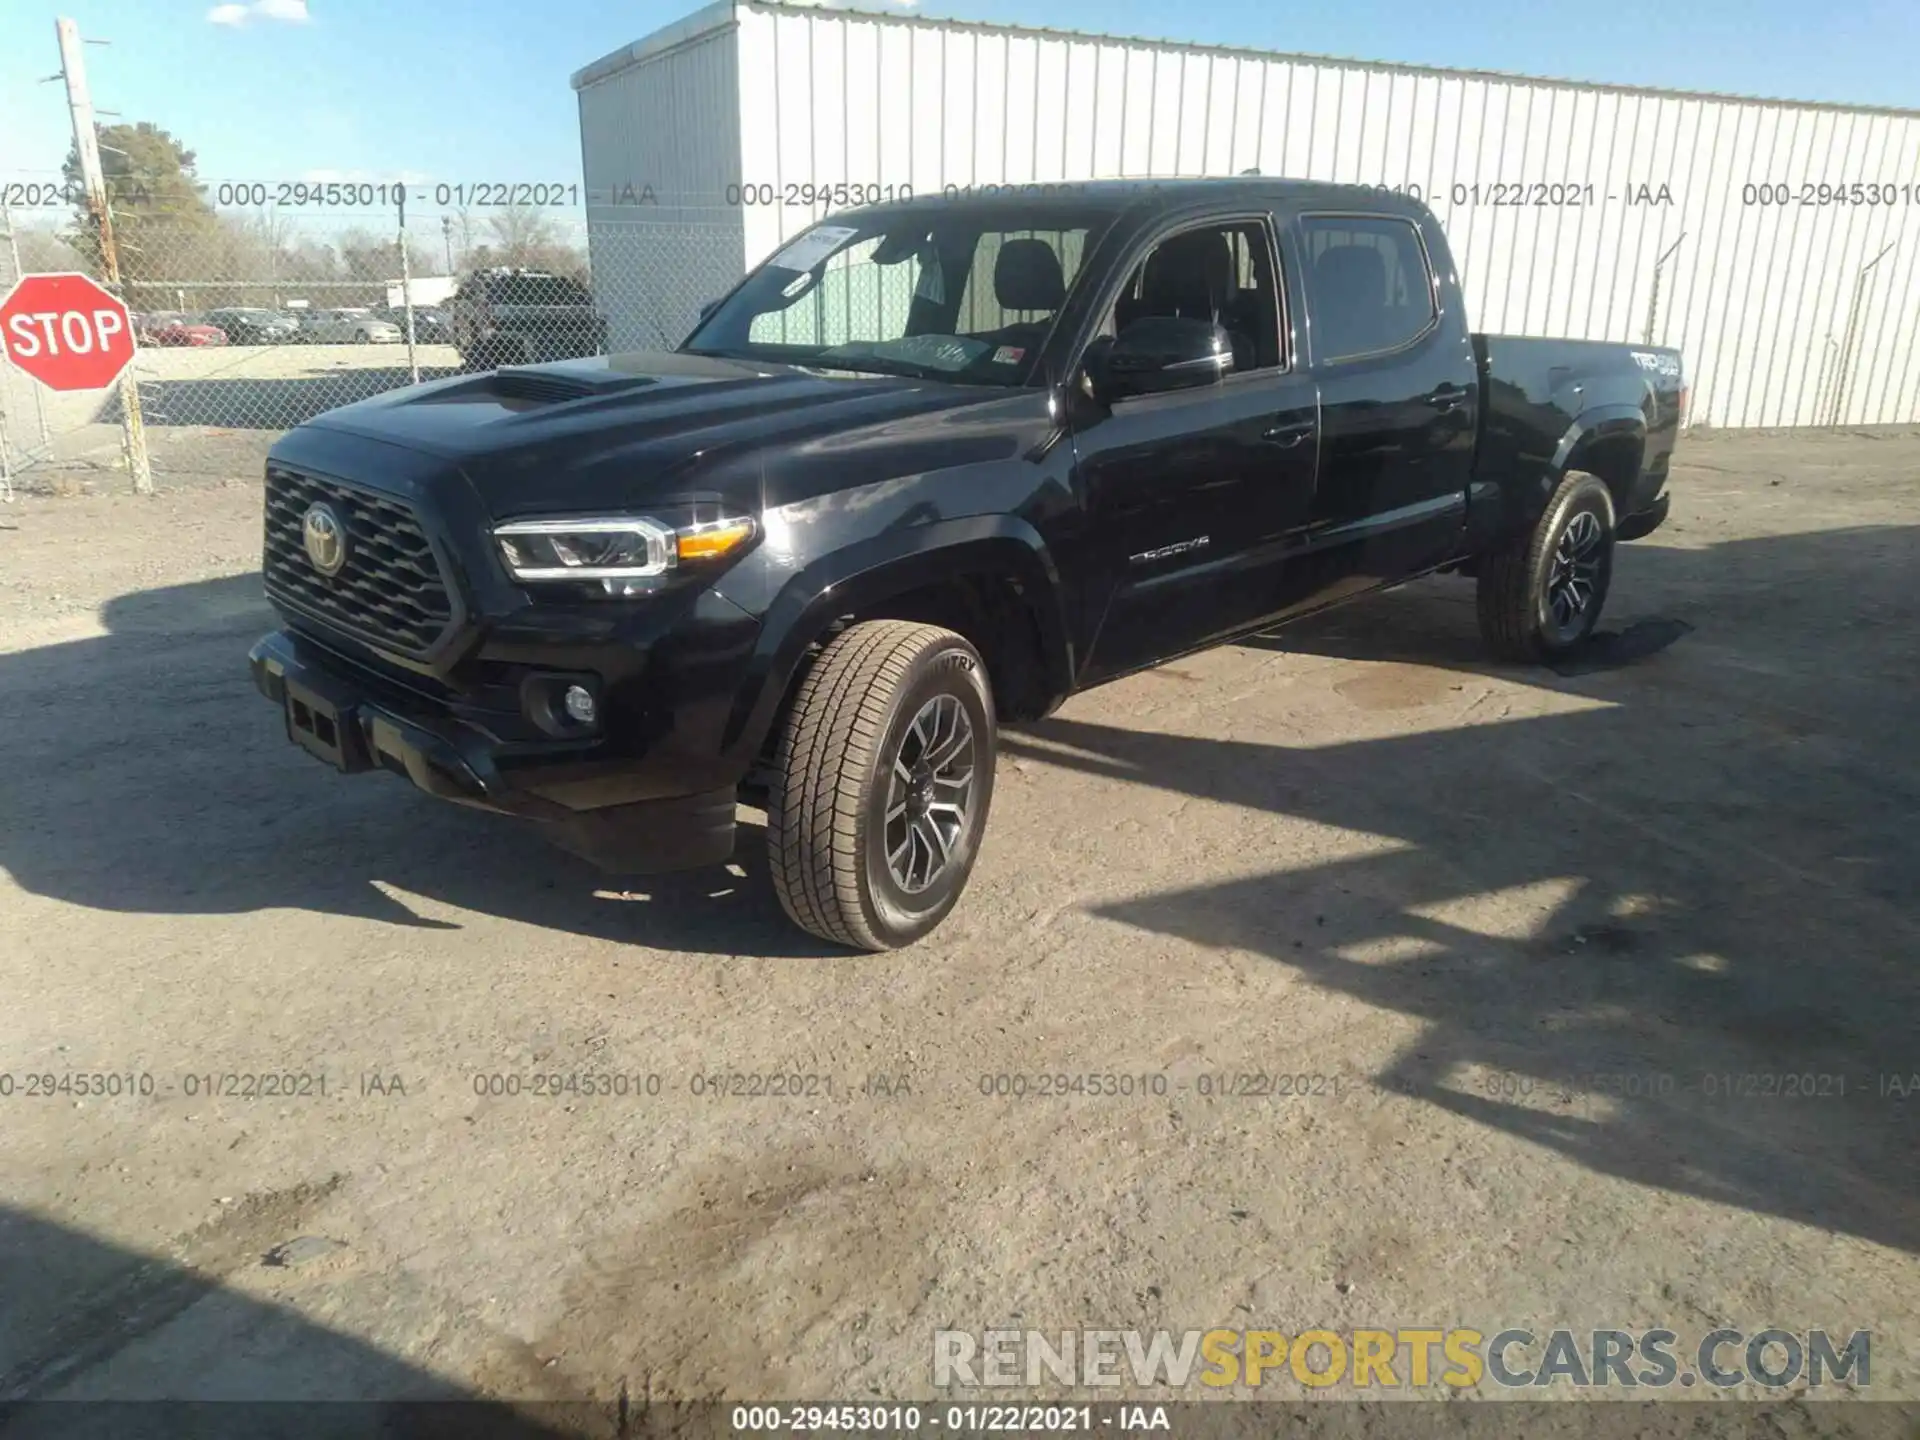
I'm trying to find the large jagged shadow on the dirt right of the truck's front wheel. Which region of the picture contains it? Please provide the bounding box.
[1008,528,1920,1252]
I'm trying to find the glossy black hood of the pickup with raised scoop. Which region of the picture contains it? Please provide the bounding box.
[307,351,1010,516]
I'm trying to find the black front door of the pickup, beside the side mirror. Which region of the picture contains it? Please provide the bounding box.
[1073,215,1317,684]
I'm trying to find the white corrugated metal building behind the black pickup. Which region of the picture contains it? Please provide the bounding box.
[572,0,1920,426]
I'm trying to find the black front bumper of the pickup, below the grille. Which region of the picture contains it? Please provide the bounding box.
[248,630,735,874]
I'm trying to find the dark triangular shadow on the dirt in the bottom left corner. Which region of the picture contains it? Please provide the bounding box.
[0,1206,591,1440]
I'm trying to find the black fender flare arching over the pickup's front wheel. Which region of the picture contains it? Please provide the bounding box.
[722,515,1077,762]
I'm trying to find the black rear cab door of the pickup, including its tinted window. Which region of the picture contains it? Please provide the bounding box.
[1286,211,1478,611]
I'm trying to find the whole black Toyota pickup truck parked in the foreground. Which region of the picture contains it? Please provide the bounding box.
[252,179,1686,948]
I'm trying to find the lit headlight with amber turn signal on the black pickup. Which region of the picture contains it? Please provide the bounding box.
[493,515,755,595]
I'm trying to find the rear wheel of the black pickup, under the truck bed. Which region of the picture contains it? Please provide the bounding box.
[1478,470,1615,664]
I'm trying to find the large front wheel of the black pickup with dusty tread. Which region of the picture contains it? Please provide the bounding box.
[766,620,995,950]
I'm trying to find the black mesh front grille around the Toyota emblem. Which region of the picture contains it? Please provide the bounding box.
[261,465,453,659]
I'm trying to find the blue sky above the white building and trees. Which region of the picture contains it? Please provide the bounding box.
[0,0,1920,216]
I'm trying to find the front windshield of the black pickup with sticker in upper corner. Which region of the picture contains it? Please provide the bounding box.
[682,209,1108,384]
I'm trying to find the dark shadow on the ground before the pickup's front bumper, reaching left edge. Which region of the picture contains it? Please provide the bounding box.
[0,574,837,958]
